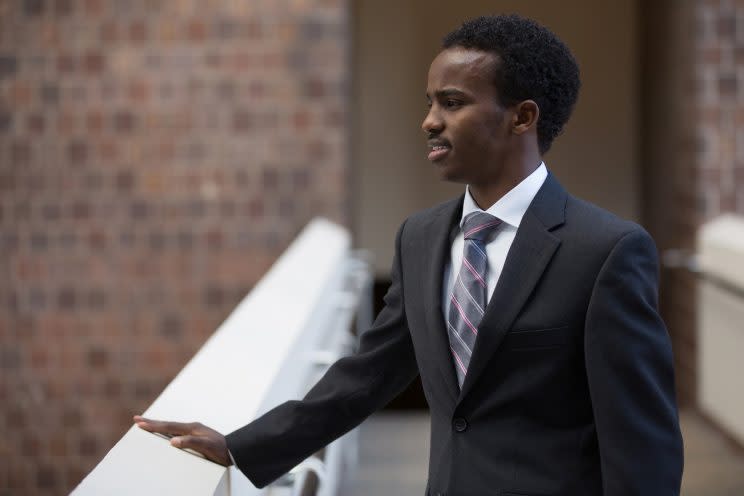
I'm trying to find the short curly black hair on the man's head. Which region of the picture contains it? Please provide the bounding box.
[442,14,581,153]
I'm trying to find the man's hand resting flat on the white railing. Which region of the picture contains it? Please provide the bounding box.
[134,415,232,467]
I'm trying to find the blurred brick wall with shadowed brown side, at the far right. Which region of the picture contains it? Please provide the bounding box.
[641,0,744,404]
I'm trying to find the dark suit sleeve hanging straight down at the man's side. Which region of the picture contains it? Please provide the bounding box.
[584,228,683,496]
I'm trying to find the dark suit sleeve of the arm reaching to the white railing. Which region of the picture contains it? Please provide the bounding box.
[226,223,418,487]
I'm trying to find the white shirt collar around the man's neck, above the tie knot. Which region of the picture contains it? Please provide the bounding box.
[460,162,548,227]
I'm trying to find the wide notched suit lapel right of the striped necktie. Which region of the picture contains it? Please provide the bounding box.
[456,174,566,399]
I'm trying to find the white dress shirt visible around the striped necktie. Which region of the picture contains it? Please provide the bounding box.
[442,162,548,322]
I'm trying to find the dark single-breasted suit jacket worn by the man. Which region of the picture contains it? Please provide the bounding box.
[227,175,682,496]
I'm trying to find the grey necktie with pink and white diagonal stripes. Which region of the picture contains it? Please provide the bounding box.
[447,212,501,387]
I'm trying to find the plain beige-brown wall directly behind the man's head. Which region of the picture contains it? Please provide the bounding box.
[351,0,640,276]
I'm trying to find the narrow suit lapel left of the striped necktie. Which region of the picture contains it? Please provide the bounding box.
[420,197,463,400]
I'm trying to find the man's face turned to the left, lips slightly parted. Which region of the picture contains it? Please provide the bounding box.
[421,47,511,185]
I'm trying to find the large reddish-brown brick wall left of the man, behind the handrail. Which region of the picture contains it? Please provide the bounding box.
[0,0,348,494]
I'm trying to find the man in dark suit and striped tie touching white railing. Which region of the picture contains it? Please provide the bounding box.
[135,16,682,496]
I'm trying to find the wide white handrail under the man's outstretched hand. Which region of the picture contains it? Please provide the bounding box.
[73,219,368,496]
